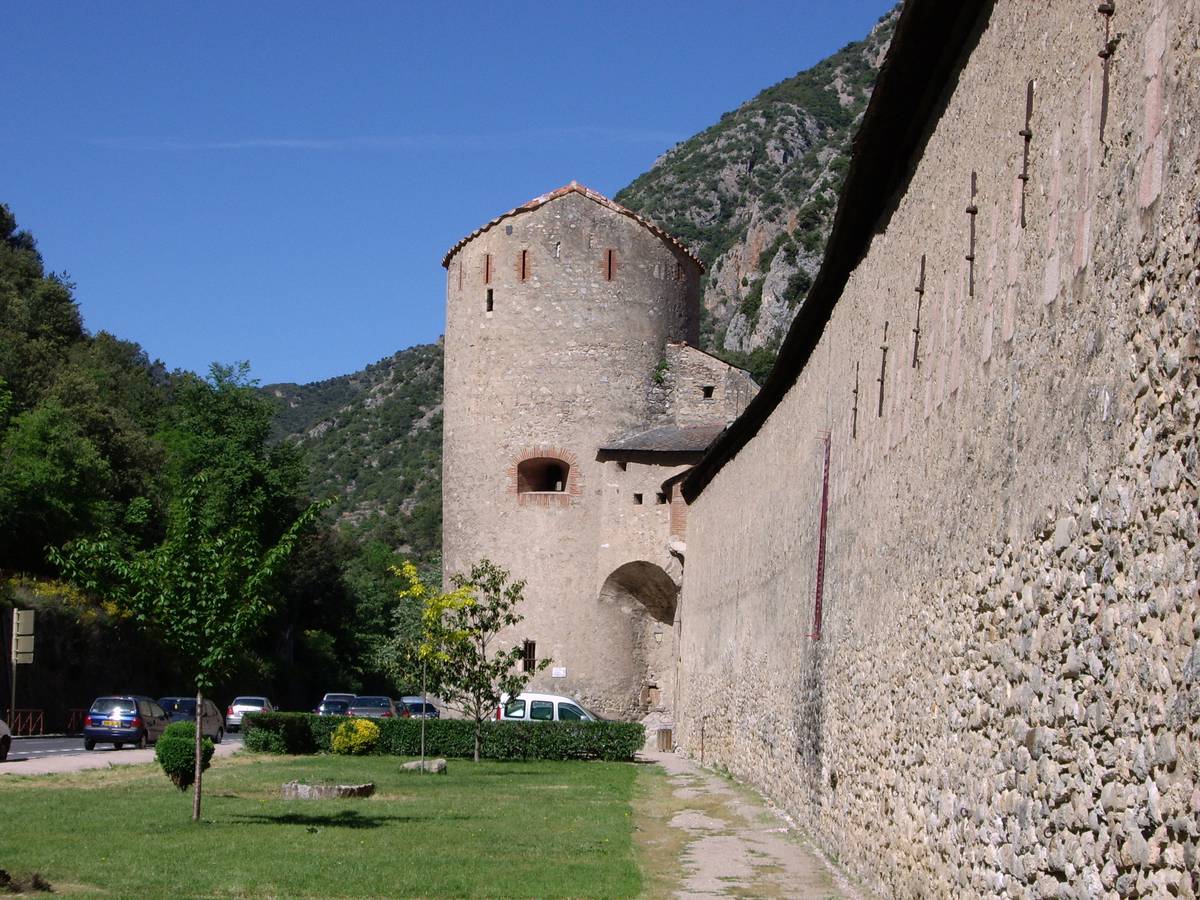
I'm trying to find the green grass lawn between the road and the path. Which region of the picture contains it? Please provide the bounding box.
[0,756,641,896]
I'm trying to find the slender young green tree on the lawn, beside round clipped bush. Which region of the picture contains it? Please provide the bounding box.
[52,474,322,821]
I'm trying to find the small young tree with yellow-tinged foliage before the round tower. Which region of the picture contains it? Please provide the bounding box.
[400,559,550,762]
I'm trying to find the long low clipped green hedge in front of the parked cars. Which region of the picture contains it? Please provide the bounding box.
[242,713,646,760]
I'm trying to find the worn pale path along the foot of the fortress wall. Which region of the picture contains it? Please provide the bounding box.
[636,752,864,900]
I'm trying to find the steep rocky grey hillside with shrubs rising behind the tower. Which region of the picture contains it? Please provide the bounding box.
[616,7,899,379]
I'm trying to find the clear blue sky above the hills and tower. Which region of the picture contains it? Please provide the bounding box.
[0,0,893,383]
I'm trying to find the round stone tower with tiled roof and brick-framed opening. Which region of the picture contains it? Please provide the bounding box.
[443,182,703,714]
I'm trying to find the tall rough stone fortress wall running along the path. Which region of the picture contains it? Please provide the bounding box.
[677,0,1200,898]
